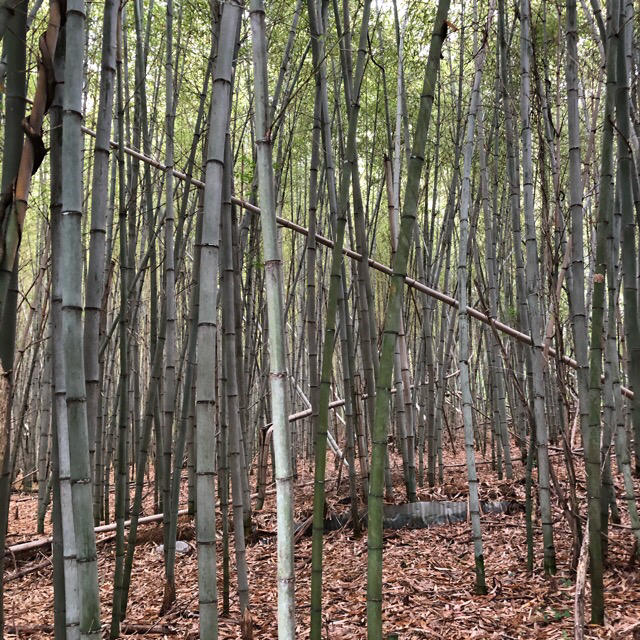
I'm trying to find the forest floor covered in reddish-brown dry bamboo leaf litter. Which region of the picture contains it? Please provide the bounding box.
[4,440,640,640]
